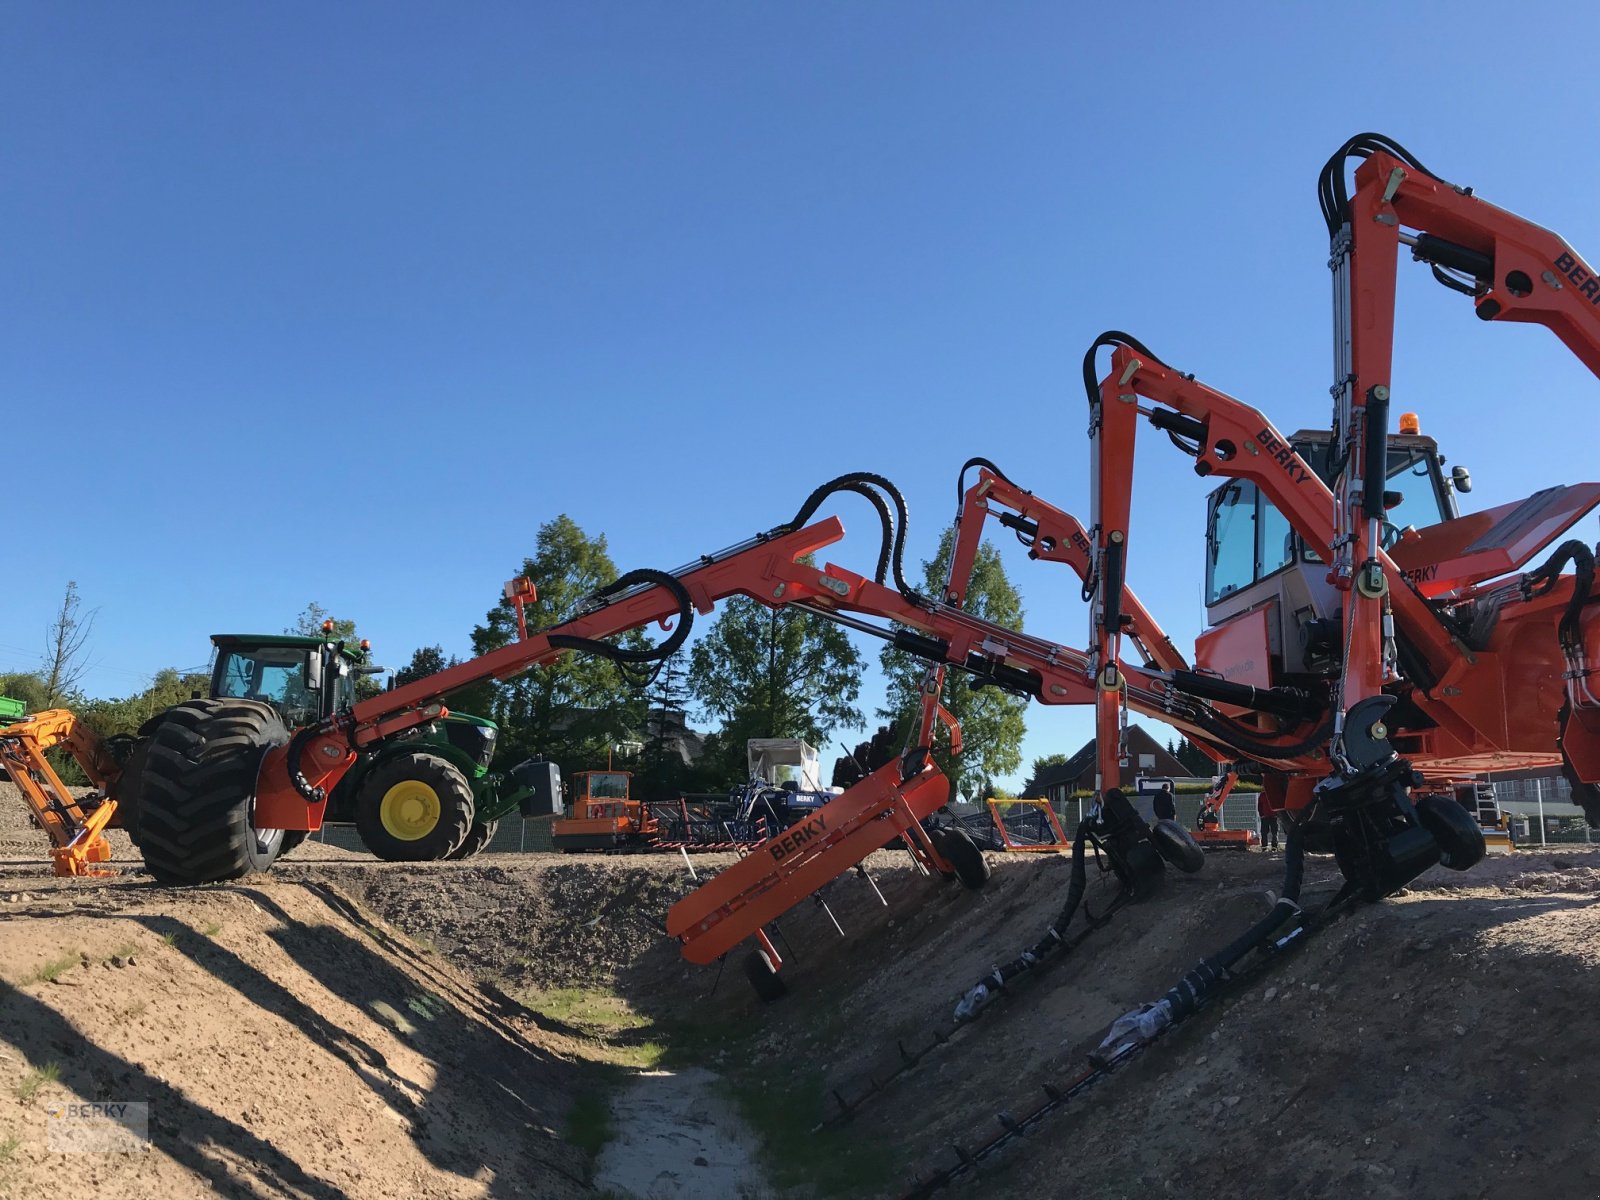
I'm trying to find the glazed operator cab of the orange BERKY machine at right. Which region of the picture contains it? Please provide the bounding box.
[1195,429,1472,686]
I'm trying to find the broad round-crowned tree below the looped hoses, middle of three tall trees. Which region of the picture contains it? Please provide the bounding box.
[688,585,862,790]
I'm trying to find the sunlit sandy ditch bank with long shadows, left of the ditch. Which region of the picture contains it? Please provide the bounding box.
[0,878,587,1200]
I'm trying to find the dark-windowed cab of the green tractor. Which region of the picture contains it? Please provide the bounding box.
[211,634,371,730]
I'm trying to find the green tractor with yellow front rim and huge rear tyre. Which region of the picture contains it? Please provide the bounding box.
[115,634,544,878]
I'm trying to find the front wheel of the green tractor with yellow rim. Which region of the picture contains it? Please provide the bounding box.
[355,754,474,862]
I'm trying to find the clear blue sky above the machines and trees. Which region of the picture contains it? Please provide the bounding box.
[0,2,1600,793]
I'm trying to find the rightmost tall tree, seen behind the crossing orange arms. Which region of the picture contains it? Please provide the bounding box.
[878,530,1027,798]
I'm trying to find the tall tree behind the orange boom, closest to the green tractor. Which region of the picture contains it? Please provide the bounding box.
[454,514,645,774]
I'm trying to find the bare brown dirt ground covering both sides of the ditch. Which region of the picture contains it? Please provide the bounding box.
[0,780,1600,1200]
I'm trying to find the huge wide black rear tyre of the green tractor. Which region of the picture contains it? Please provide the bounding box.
[134,699,290,883]
